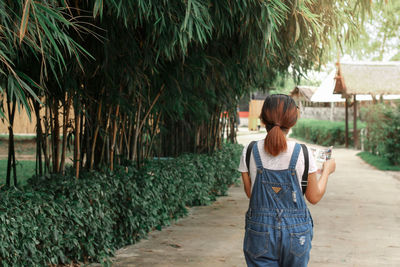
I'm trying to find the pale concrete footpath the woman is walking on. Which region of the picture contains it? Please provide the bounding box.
[105,134,400,267]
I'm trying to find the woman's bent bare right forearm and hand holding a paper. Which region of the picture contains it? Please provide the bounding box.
[306,159,336,205]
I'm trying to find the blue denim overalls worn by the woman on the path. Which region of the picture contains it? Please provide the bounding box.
[243,143,313,267]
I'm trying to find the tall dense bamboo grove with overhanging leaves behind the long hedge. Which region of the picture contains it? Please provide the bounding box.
[0,0,371,185]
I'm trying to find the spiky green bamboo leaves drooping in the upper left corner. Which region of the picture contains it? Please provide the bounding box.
[0,0,88,118]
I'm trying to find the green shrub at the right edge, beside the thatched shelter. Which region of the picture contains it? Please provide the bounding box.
[363,104,400,165]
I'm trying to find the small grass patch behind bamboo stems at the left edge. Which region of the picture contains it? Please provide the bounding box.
[0,159,35,186]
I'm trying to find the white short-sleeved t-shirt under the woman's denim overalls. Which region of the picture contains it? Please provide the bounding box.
[238,140,317,194]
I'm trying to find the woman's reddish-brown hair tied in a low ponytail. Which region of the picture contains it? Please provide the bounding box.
[260,94,298,156]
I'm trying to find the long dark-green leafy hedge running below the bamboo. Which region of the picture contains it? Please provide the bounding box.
[0,144,242,266]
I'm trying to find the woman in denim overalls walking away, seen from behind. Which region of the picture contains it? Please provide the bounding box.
[239,94,336,267]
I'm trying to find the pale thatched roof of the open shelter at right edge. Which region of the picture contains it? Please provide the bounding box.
[334,62,400,95]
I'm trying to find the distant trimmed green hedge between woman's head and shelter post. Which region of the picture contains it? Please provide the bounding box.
[291,119,365,146]
